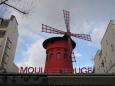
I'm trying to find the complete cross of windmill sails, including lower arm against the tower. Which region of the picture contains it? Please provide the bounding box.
[42,10,91,61]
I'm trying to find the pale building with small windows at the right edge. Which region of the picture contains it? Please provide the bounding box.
[94,20,115,73]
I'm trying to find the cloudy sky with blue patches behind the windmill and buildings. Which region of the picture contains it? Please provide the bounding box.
[0,0,115,70]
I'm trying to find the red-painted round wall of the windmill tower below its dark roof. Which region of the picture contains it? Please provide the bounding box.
[43,37,73,73]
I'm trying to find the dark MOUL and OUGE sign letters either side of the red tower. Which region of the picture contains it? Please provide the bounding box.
[19,67,93,74]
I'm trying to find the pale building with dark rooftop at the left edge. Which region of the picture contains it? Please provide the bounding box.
[0,15,18,73]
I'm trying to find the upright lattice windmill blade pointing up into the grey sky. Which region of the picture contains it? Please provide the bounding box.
[63,10,70,33]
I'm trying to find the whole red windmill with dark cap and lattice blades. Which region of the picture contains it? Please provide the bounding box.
[42,10,91,73]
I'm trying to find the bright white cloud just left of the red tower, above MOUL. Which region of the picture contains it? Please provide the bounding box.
[17,32,45,67]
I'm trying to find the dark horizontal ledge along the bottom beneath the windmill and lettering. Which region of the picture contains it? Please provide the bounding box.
[0,73,115,86]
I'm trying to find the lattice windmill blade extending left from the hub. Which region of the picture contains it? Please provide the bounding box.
[42,24,65,34]
